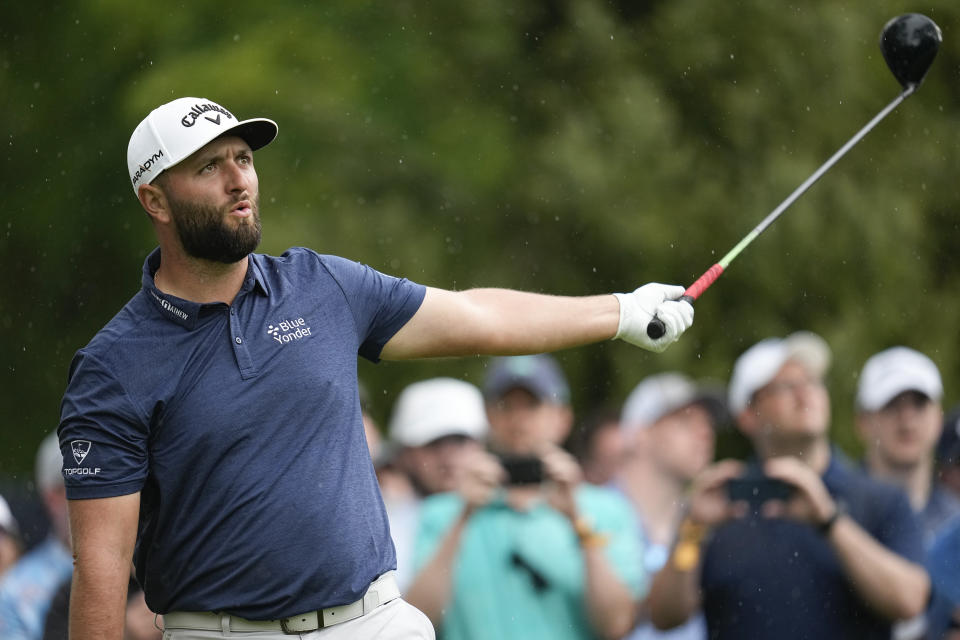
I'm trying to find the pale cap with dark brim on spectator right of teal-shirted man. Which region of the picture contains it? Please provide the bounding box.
[620,372,724,433]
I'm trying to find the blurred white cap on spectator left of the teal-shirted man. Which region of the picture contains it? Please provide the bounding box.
[389,378,488,447]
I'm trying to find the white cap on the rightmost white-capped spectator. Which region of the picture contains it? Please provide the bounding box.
[857,347,943,411]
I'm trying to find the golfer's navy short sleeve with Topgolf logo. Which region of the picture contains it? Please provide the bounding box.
[57,351,148,500]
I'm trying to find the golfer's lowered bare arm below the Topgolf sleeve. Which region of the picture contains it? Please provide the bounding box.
[69,493,140,640]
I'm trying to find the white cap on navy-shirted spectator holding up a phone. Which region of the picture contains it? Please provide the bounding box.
[727,331,831,416]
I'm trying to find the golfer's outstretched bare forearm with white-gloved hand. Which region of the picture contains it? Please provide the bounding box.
[381,284,693,360]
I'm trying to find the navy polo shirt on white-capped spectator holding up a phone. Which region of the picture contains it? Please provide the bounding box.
[701,450,923,640]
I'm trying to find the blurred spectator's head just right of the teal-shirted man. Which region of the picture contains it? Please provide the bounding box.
[567,407,623,487]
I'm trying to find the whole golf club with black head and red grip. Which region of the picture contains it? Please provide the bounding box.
[647,13,943,340]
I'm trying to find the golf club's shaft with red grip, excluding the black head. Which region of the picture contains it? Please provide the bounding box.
[647,85,917,340]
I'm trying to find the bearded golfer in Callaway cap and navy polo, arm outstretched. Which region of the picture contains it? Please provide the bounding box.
[59,98,693,640]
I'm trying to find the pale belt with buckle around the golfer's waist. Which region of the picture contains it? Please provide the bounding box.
[163,571,400,634]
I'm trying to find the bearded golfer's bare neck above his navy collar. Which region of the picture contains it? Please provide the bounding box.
[153,251,250,304]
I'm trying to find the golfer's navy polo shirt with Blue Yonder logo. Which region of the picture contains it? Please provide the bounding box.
[59,248,425,620]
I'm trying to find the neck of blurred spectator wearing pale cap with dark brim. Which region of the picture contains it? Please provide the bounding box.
[618,461,685,544]
